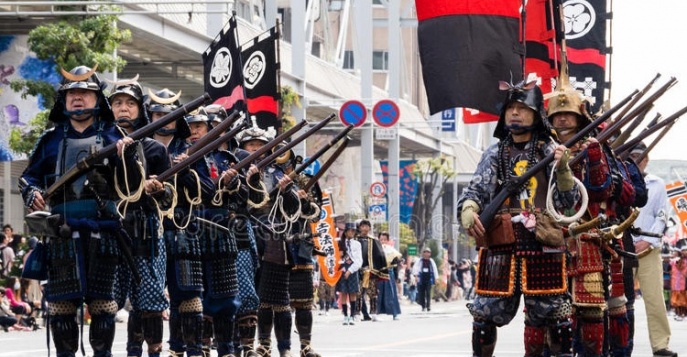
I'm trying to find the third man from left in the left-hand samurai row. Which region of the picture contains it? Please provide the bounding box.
[148,89,215,356]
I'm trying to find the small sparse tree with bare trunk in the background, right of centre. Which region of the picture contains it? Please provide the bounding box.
[413,157,456,249]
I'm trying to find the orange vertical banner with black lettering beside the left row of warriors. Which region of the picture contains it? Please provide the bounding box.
[312,191,341,286]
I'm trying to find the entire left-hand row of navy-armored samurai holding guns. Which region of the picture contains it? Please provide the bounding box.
[20,66,336,357]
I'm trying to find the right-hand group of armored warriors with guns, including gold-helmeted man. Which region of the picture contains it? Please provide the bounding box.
[458,61,677,357]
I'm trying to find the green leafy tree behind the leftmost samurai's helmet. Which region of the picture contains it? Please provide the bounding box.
[9,9,131,154]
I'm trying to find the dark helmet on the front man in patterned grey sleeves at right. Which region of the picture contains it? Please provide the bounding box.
[494,81,551,140]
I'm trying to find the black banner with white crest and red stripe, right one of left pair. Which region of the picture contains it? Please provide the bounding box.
[241,27,281,130]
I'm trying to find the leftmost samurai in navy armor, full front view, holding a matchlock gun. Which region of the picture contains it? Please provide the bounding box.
[19,66,142,357]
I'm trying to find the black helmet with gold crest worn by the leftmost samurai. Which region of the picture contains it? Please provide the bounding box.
[48,64,114,123]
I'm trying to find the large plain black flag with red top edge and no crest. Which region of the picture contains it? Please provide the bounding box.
[415,0,522,122]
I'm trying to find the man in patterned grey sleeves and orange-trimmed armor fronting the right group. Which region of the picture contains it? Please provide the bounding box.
[458,82,580,357]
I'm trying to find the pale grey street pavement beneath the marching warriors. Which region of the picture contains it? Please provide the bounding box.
[0,294,687,357]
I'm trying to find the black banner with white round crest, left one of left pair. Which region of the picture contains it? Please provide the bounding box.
[203,16,245,112]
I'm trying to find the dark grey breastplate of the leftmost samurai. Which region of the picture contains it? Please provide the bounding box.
[55,135,107,200]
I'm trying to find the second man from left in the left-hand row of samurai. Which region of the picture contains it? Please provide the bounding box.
[109,80,172,357]
